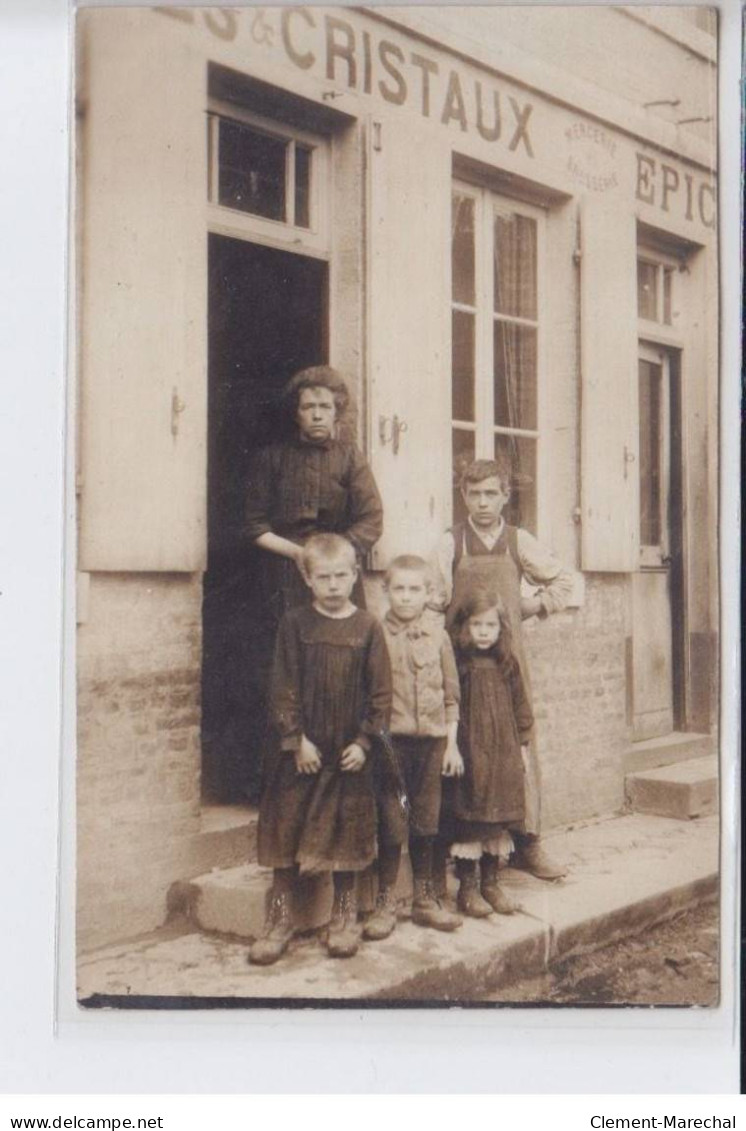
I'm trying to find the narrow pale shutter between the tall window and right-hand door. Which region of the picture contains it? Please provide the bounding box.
[580,197,640,572]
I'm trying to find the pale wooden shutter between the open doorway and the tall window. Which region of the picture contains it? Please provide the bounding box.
[368,114,451,569]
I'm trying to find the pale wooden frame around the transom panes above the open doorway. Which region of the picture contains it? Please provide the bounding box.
[207,98,331,259]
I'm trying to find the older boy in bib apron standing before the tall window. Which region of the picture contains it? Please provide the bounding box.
[432,459,573,880]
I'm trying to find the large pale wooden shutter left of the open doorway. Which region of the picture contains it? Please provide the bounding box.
[77,8,207,570]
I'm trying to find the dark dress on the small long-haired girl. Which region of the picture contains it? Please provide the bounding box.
[454,640,534,841]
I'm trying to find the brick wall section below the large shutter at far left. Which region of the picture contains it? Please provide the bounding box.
[77,575,201,949]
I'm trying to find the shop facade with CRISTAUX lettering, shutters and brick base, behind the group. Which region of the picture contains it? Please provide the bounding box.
[77,8,718,948]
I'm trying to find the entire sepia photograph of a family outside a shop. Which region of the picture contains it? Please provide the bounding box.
[69,3,723,1011]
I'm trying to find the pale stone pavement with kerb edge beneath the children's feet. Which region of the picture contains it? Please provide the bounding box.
[78,813,719,1004]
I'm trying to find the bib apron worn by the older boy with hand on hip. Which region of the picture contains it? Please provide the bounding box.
[445,523,540,835]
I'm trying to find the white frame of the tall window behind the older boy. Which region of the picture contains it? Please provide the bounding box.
[449,178,547,535]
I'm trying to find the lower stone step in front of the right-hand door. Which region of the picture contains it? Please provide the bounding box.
[625,754,718,821]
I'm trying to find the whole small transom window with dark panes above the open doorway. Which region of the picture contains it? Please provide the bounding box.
[208,100,329,253]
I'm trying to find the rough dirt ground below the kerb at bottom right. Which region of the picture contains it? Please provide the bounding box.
[489,904,719,1005]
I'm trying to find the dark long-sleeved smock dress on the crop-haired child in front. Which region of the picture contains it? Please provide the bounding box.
[258,606,391,872]
